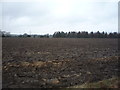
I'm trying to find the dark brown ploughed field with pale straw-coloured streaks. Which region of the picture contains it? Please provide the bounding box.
[2,38,119,88]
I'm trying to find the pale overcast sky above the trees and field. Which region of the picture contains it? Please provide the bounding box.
[2,0,118,34]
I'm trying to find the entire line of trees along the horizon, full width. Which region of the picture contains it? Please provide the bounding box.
[0,31,120,38]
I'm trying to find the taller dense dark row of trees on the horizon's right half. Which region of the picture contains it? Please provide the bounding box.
[53,31,120,38]
